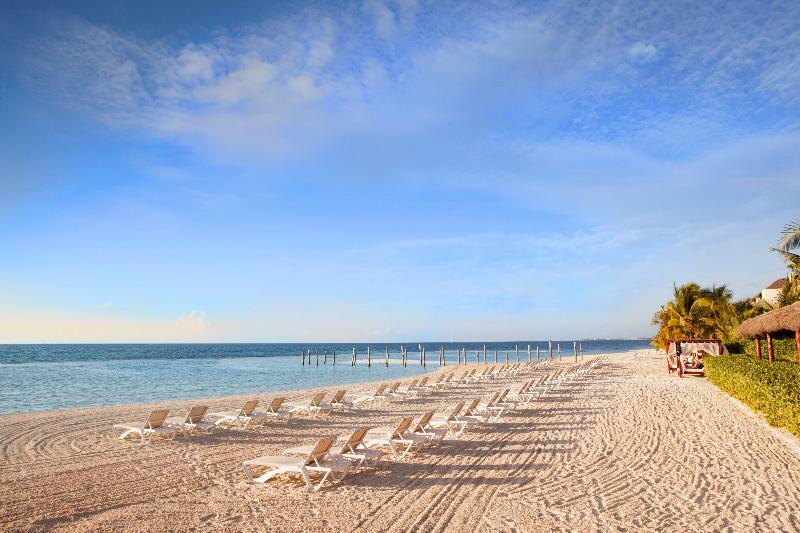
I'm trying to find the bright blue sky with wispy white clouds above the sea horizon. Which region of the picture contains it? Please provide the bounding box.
[0,0,800,343]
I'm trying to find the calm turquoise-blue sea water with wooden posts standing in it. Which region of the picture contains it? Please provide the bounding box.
[0,340,649,413]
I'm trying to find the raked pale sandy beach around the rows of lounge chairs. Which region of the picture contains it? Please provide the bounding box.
[0,351,800,531]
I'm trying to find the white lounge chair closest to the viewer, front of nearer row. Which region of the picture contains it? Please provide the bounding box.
[242,437,351,492]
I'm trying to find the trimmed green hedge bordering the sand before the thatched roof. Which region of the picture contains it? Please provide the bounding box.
[705,355,800,437]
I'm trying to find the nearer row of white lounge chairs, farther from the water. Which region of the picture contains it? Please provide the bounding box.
[242,359,604,491]
